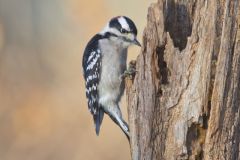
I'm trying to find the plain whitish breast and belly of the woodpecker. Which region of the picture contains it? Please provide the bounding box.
[98,39,127,109]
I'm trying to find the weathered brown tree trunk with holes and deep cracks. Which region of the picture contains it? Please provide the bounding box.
[126,0,240,160]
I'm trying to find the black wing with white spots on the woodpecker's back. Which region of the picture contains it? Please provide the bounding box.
[82,34,104,135]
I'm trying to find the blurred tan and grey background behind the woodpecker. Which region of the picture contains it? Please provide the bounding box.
[0,0,154,160]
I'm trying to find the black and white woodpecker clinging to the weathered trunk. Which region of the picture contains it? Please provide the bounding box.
[82,16,141,140]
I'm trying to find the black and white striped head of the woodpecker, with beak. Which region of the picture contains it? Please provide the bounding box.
[101,16,141,47]
